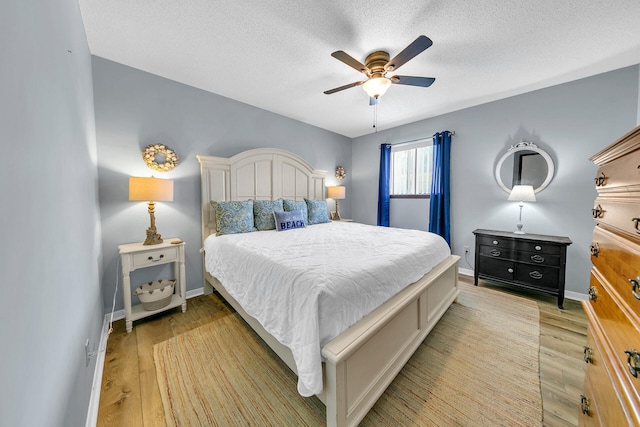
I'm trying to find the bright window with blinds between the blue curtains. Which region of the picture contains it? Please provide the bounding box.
[389,142,433,197]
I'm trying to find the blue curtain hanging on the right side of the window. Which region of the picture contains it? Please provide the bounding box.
[429,130,451,246]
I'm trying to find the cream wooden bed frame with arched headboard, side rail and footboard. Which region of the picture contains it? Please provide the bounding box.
[197,149,460,427]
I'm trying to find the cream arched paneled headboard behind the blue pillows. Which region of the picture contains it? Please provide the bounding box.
[196,148,327,241]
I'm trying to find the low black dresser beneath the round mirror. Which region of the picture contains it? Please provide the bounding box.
[473,229,571,308]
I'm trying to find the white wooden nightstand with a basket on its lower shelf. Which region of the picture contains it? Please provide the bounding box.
[118,238,187,332]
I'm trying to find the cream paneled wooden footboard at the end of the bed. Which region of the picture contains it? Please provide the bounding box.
[322,255,460,427]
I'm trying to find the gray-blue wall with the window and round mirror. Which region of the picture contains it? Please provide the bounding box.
[351,66,639,294]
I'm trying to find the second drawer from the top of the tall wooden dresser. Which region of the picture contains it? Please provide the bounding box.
[591,193,640,242]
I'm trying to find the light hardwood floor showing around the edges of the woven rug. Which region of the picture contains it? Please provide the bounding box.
[98,276,587,427]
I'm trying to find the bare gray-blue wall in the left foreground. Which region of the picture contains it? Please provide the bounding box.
[0,0,104,426]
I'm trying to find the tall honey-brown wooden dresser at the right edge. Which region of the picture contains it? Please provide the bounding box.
[580,126,640,426]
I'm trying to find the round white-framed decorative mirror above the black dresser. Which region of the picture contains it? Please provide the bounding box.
[495,141,554,193]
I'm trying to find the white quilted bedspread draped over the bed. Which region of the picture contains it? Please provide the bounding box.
[204,222,451,396]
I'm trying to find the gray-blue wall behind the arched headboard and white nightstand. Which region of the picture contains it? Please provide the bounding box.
[93,57,351,309]
